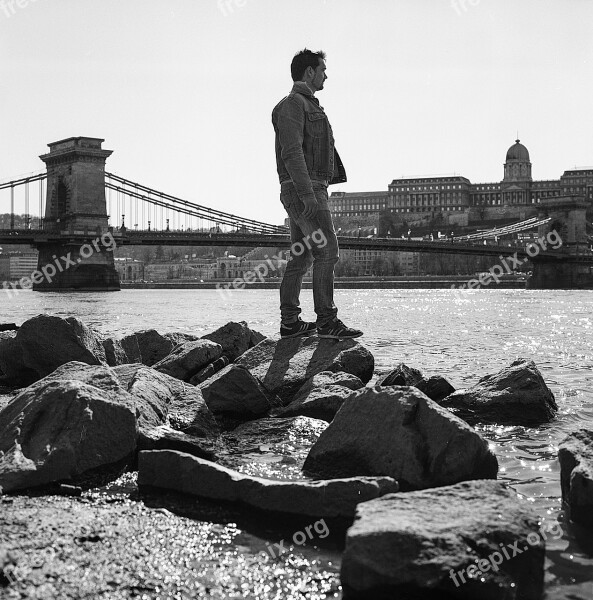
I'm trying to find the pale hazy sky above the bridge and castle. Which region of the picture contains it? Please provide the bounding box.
[0,0,593,223]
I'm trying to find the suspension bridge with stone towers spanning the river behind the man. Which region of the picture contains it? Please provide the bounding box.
[0,137,593,290]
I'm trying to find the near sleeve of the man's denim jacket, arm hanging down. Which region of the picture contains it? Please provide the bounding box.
[278,97,315,200]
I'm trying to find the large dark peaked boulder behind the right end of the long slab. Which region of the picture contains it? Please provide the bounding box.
[304,386,498,490]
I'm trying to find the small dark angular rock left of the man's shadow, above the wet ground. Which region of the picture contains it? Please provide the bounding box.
[198,364,272,416]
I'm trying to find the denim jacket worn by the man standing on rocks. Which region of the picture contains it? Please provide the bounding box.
[272,81,346,204]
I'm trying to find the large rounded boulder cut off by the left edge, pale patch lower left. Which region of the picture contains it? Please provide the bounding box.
[0,380,137,491]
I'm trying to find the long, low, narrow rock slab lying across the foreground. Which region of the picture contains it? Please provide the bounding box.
[138,450,398,517]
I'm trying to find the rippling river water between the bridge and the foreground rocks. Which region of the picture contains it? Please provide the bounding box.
[0,289,593,597]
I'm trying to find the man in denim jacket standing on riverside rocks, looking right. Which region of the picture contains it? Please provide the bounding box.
[272,48,362,339]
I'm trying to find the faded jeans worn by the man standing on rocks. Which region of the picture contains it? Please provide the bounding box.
[280,181,339,327]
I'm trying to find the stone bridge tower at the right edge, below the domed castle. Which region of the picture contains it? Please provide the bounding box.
[528,196,593,289]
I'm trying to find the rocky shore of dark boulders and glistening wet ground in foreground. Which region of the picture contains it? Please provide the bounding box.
[0,315,593,600]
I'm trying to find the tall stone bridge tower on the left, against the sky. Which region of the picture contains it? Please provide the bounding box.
[33,137,120,291]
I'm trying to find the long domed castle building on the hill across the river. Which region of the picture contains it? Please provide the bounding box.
[329,140,593,217]
